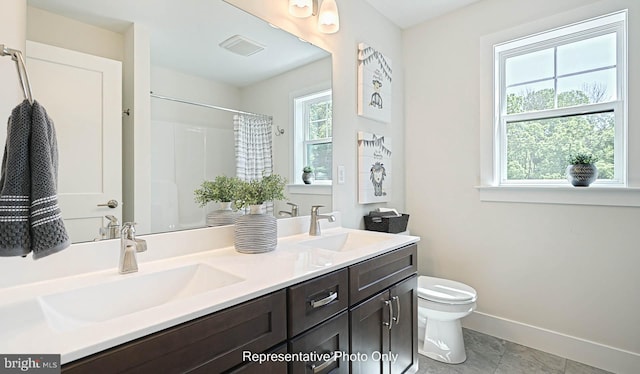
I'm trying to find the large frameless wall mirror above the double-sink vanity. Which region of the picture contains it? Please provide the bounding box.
[27,0,332,242]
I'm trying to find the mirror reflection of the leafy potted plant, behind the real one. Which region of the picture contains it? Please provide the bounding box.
[194,175,242,226]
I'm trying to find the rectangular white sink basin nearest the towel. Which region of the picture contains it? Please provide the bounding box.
[38,264,243,331]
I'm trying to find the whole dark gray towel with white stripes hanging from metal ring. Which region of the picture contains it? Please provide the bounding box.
[0,100,70,259]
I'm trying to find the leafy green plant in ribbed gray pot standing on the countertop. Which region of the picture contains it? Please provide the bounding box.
[234,174,286,253]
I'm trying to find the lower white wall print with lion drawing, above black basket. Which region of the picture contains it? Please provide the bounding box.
[358,131,393,204]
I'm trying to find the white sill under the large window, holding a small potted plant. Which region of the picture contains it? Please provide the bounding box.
[476,185,640,207]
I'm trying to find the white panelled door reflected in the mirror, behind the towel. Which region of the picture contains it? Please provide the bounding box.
[26,41,122,242]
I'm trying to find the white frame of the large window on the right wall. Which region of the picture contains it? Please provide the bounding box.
[493,11,627,187]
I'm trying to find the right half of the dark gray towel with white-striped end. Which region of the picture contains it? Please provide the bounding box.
[29,101,71,259]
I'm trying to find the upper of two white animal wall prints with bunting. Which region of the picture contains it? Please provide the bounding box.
[358,43,393,123]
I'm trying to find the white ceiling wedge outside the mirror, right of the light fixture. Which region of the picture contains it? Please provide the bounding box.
[364,0,479,29]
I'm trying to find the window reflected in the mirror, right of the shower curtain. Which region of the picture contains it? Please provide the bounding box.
[294,90,333,184]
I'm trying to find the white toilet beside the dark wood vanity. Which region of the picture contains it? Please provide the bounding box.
[418,276,477,364]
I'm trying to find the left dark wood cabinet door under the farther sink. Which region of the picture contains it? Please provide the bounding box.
[349,291,391,374]
